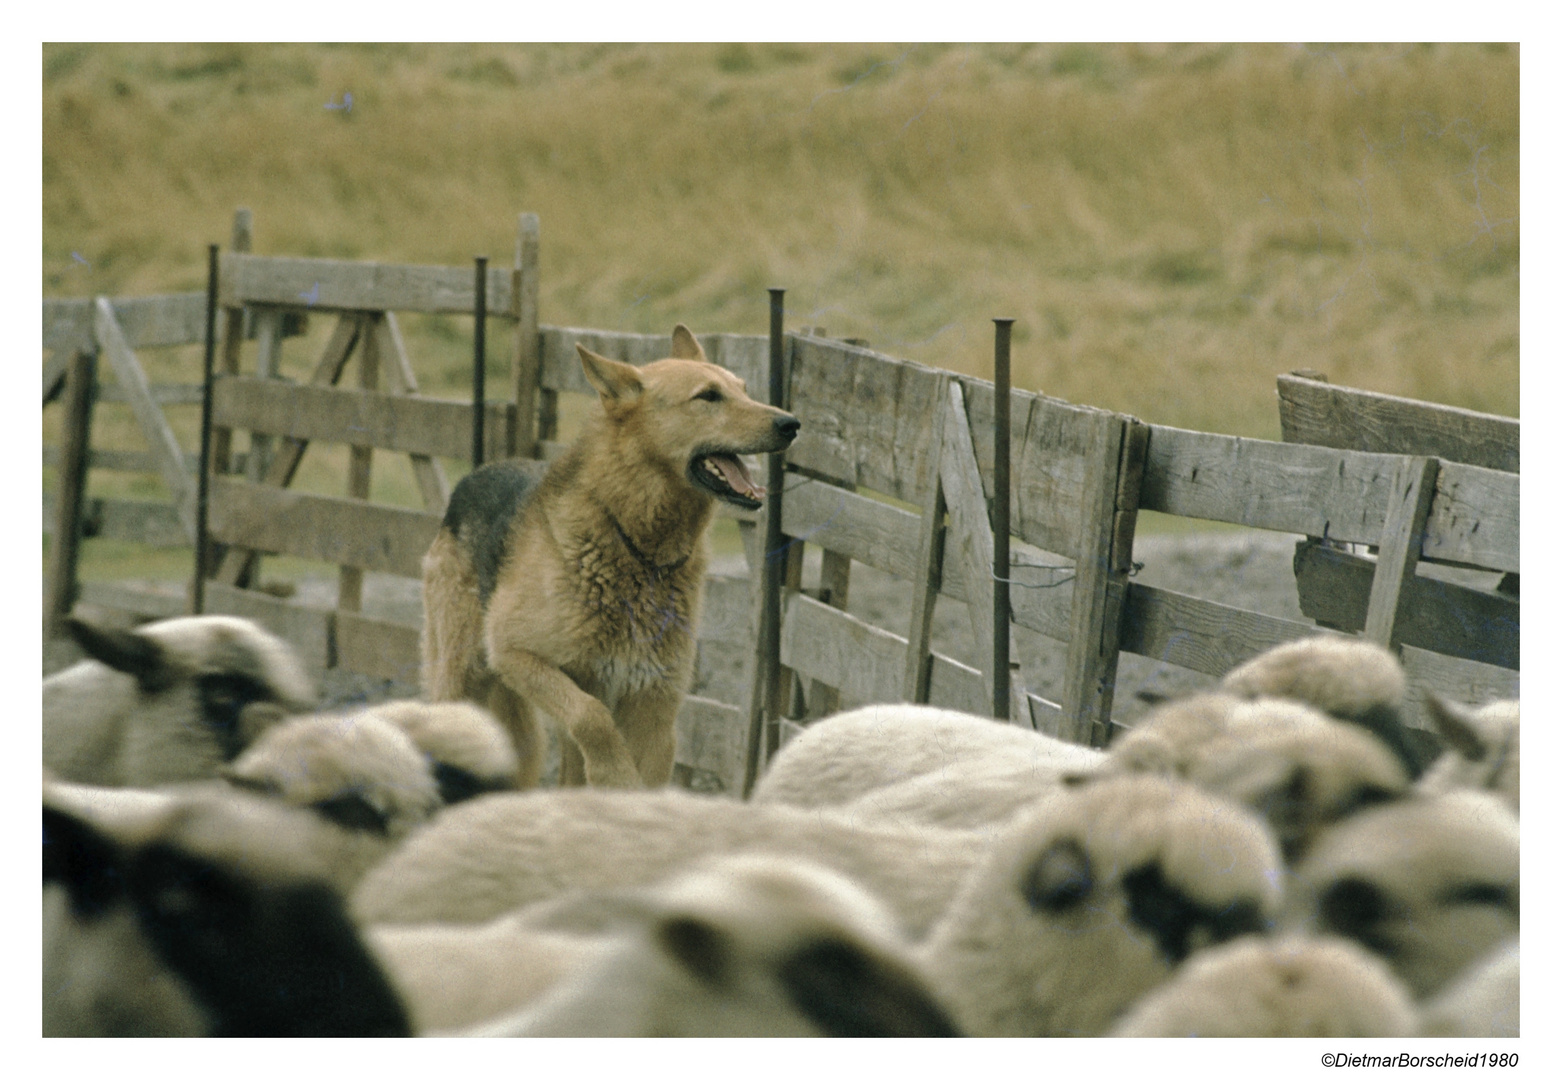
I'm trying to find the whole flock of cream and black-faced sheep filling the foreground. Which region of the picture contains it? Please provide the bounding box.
[42,616,1518,1036]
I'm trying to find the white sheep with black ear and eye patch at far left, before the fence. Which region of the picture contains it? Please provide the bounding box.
[44,616,314,786]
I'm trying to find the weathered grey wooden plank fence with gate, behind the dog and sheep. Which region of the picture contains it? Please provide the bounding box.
[45,216,1518,791]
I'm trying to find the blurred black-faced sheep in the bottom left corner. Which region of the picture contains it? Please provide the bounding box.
[42,796,411,1036]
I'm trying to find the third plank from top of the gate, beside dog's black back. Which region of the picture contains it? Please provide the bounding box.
[209,477,439,578]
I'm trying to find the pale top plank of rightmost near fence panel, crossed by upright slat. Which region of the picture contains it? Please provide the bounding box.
[1139,425,1518,570]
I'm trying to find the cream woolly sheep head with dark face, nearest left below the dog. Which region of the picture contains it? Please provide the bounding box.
[222,713,444,880]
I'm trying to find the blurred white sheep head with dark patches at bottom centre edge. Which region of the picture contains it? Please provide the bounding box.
[473,855,958,1038]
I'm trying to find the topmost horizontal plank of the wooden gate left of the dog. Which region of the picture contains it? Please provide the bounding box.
[217,253,511,314]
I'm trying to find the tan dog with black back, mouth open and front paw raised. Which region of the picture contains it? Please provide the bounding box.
[422,324,801,788]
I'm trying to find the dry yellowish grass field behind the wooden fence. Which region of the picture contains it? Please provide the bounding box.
[42,44,1518,584]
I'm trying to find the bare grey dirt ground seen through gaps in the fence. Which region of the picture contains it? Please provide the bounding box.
[44,531,1303,734]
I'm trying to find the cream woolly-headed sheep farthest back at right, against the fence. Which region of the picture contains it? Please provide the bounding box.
[1220,635,1428,780]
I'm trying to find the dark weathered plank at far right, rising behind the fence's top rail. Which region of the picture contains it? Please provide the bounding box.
[1275,375,1518,472]
